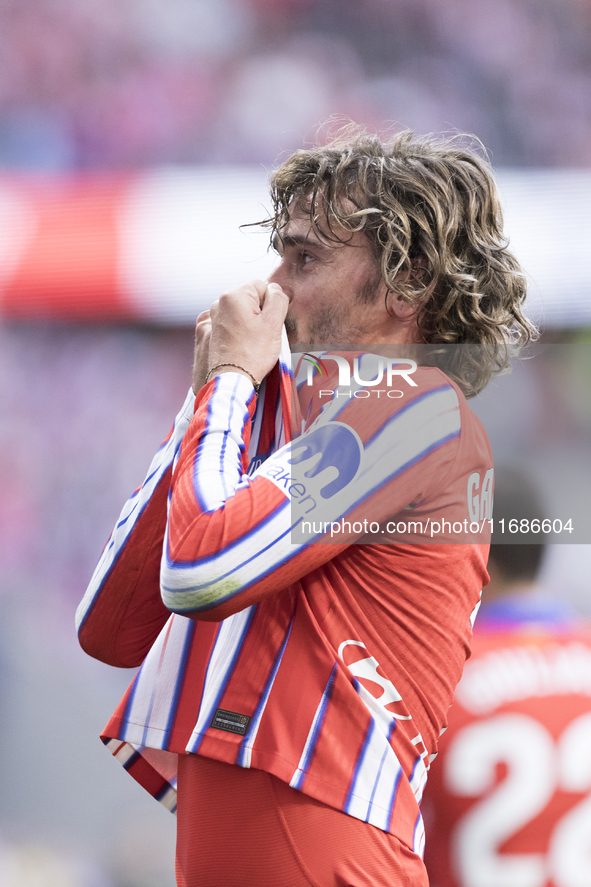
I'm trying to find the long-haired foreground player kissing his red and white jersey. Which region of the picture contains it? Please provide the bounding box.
[78,129,533,887]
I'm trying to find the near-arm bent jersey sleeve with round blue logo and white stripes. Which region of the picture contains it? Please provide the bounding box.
[160,373,460,621]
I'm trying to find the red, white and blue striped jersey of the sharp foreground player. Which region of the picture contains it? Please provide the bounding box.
[78,344,492,853]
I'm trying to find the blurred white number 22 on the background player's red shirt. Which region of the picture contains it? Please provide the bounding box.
[443,701,591,887]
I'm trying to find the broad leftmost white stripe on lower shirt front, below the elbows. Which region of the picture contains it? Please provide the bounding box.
[121,616,195,749]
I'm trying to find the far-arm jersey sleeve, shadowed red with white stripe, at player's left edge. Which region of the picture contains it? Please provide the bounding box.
[76,391,195,668]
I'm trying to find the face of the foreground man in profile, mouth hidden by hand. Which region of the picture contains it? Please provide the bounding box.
[269,209,386,345]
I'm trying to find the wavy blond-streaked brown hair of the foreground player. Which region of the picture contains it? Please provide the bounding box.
[263,124,537,395]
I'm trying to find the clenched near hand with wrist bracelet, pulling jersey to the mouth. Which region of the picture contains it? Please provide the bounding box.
[208,280,289,382]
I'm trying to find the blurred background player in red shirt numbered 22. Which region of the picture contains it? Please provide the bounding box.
[423,470,591,887]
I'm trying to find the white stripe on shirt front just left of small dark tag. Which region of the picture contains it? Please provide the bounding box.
[186,604,256,753]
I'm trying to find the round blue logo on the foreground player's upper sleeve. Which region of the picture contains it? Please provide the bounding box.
[288,422,361,499]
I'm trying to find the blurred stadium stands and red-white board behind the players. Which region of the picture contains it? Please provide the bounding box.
[0,0,591,887]
